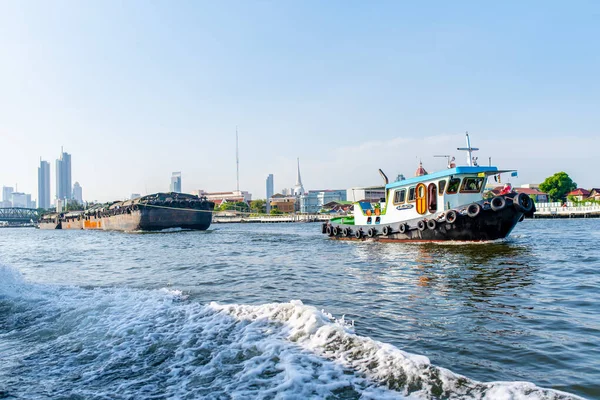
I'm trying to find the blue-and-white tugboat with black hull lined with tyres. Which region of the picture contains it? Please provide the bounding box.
[322,134,535,242]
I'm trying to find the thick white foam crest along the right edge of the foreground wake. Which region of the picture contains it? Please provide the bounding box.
[210,300,577,399]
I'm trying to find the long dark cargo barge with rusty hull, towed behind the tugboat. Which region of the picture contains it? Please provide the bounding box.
[39,193,215,231]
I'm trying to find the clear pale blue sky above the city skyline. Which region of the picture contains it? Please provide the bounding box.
[0,0,600,201]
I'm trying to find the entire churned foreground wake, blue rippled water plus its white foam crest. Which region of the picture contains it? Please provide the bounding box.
[0,266,576,399]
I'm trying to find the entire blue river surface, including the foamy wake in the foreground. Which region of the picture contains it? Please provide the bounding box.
[0,220,600,399]
